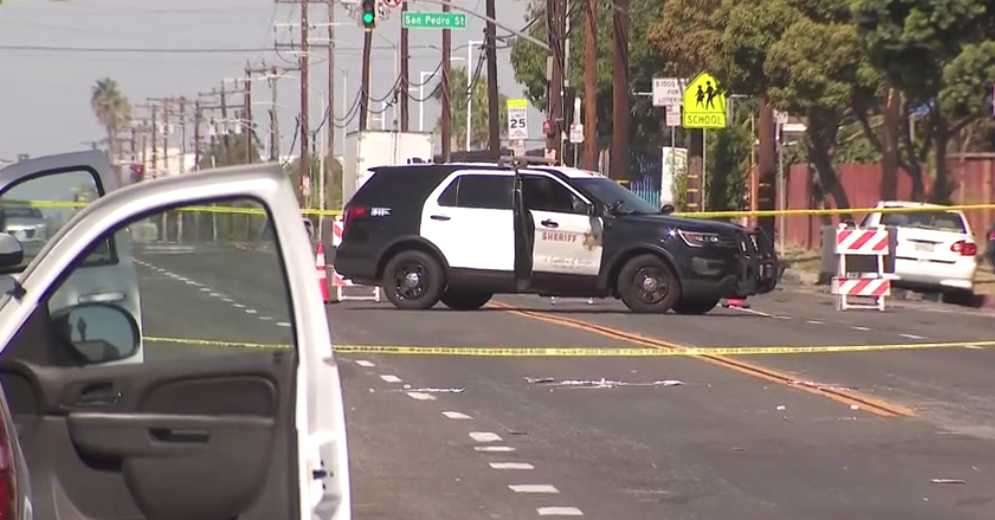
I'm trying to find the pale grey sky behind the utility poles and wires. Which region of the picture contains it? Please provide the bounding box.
[0,0,541,160]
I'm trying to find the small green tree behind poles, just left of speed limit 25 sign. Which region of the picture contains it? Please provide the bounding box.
[432,62,508,150]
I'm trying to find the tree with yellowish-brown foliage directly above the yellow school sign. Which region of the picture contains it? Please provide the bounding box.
[649,0,878,217]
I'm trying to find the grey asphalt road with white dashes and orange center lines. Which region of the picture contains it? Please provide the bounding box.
[143,248,995,520]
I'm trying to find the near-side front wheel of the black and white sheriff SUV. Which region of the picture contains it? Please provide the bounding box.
[616,255,681,314]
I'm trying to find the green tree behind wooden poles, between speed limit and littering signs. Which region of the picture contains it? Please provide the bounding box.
[511,0,665,146]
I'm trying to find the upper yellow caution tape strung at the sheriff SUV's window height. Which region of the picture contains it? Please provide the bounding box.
[13,200,995,219]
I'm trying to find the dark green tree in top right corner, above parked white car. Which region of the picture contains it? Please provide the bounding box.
[852,0,995,202]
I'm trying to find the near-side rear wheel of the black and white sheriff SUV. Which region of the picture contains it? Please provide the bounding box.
[382,250,446,310]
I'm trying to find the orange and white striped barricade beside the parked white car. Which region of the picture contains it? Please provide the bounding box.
[832,225,891,311]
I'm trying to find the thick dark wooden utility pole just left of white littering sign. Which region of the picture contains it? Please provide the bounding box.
[608,0,629,182]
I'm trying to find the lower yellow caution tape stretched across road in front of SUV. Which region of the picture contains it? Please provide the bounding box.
[145,337,995,357]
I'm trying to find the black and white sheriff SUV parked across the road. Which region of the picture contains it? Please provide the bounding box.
[334,159,777,314]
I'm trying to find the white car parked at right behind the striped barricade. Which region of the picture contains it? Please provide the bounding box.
[860,201,978,293]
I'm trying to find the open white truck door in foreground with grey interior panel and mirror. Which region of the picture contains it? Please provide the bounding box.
[0,164,351,520]
